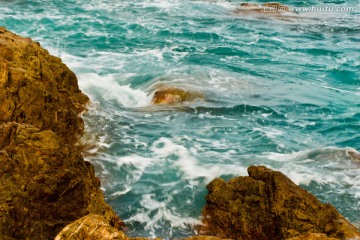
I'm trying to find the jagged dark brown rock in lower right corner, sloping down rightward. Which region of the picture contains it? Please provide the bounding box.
[200,166,360,240]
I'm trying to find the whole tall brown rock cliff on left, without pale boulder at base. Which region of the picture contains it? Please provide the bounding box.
[0,27,123,240]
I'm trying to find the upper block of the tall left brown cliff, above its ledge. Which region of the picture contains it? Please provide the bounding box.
[0,27,89,143]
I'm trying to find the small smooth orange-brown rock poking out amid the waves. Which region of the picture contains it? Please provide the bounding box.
[152,87,204,104]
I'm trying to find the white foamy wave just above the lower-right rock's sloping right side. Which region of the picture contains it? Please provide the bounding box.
[263,147,360,189]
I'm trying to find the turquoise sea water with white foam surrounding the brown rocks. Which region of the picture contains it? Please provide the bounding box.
[0,0,360,239]
